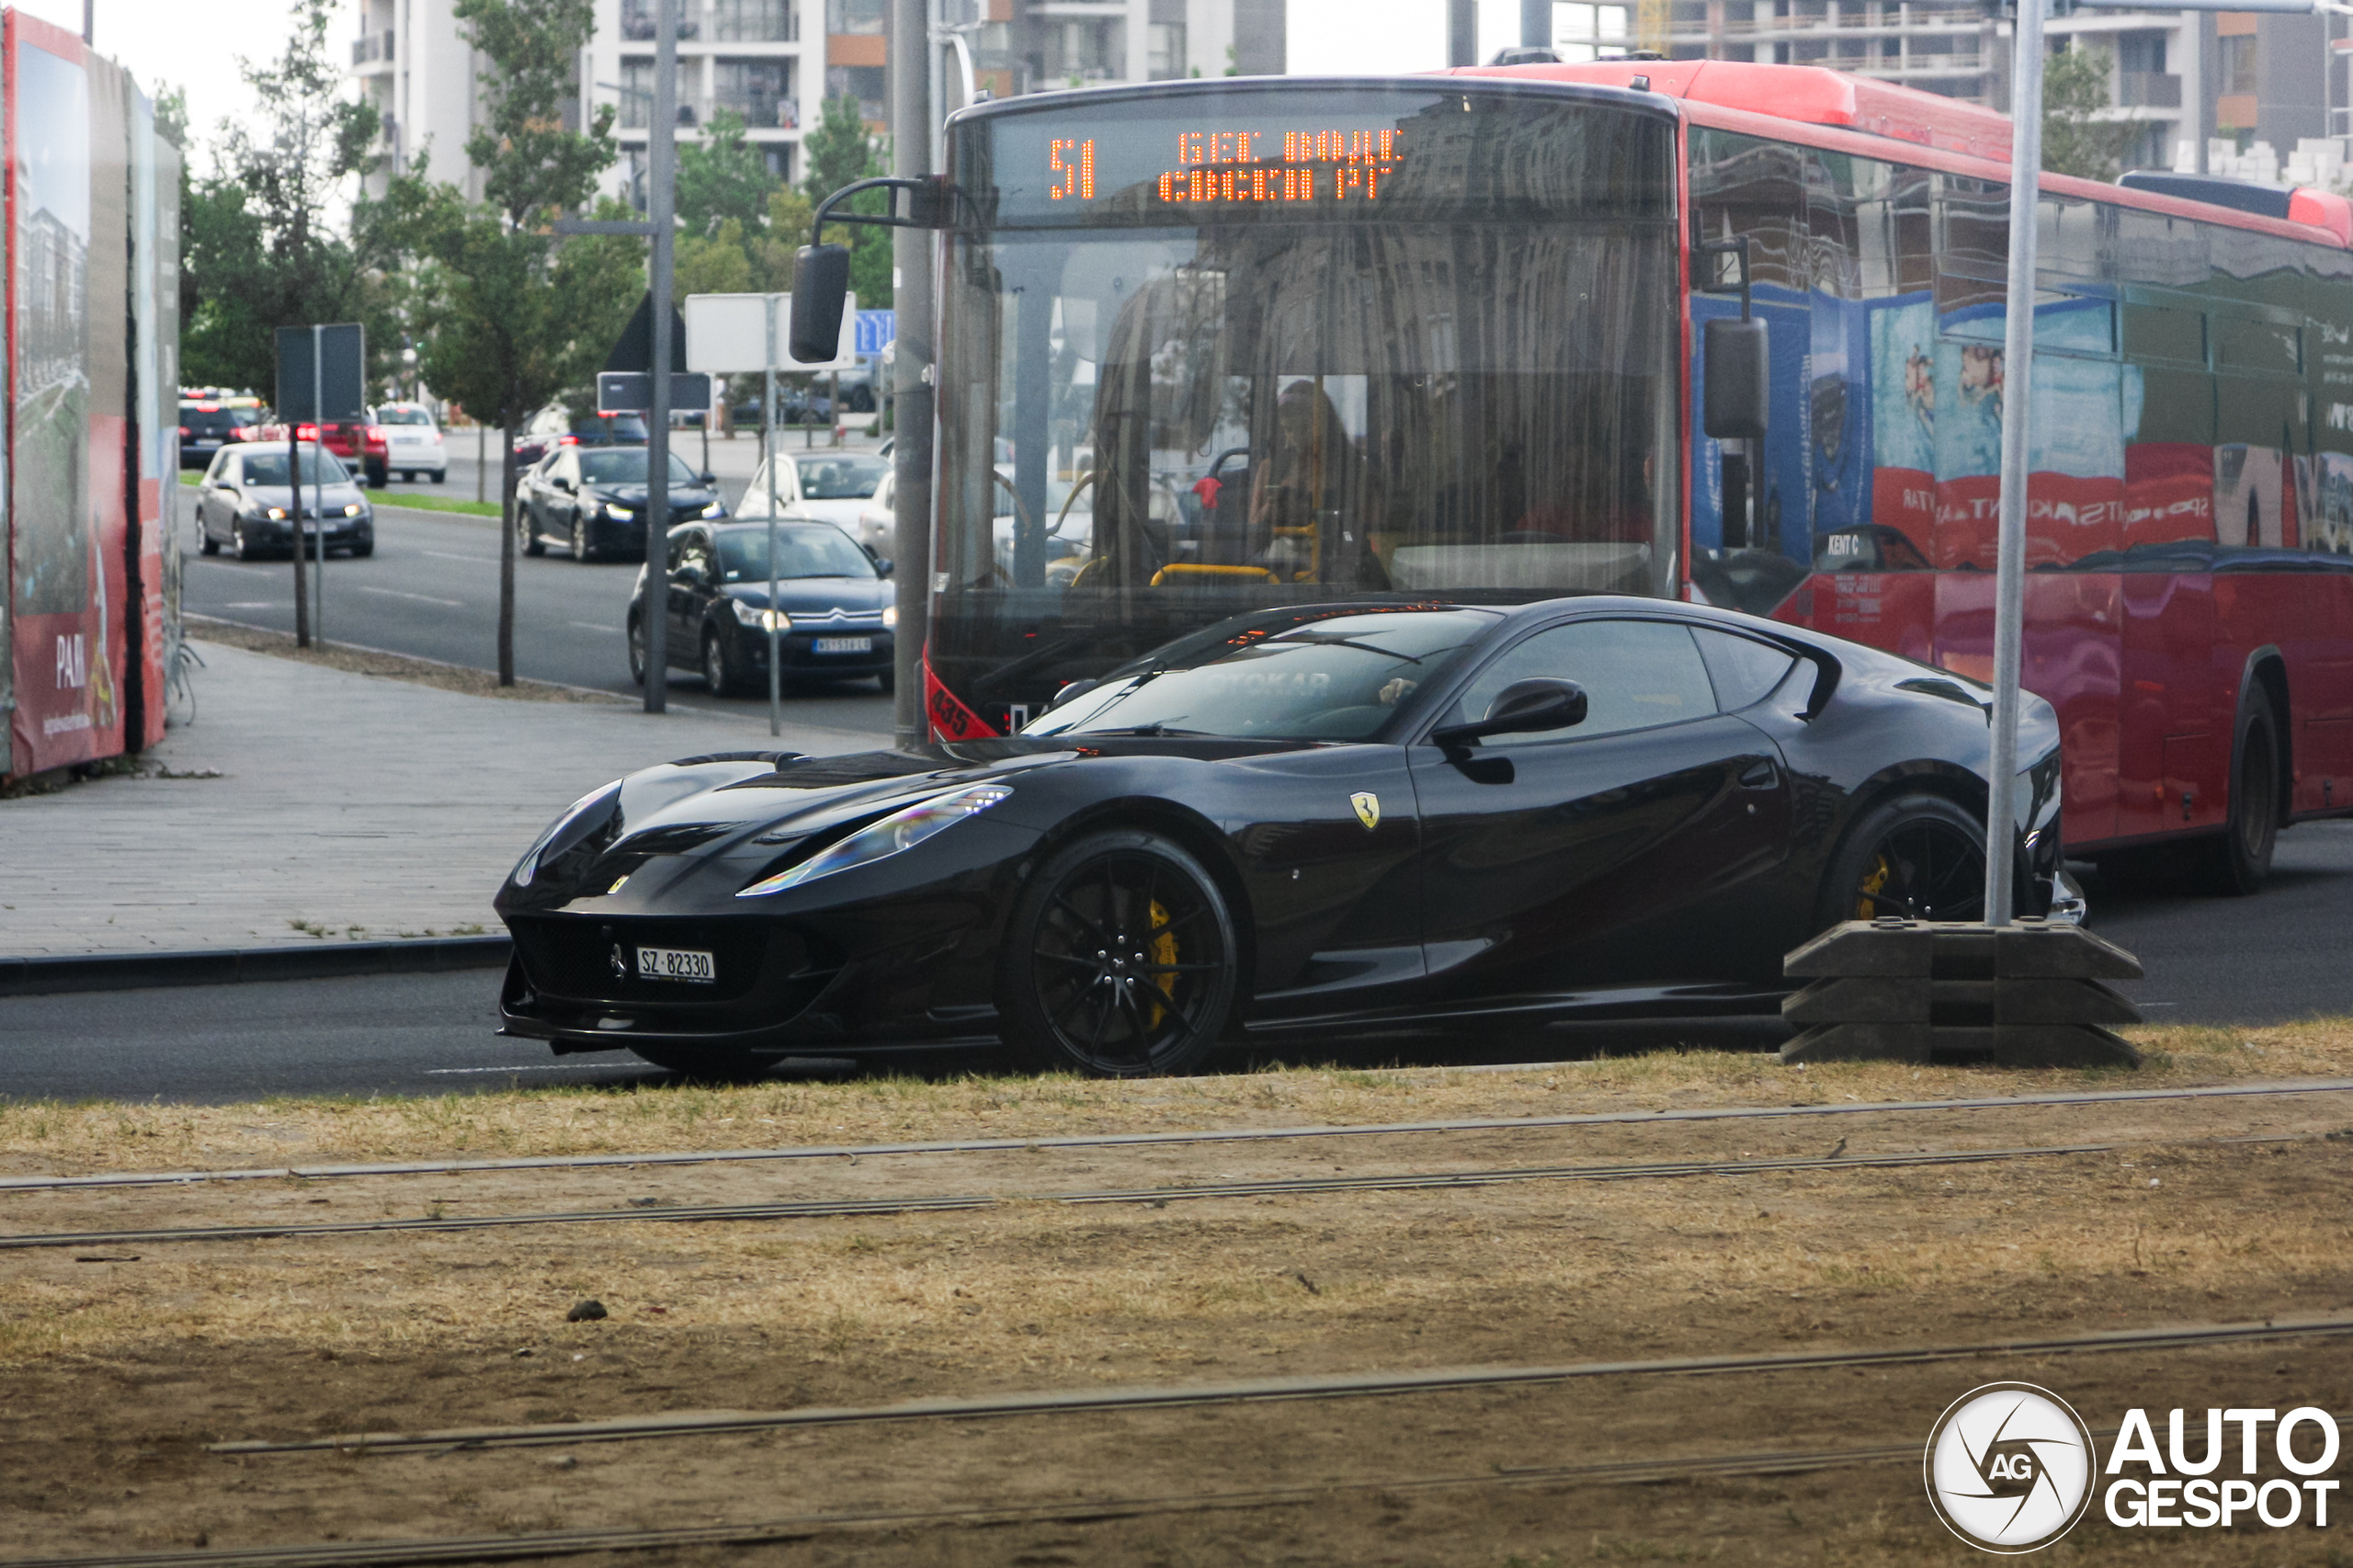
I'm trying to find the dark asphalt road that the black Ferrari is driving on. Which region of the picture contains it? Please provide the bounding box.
[0,822,2353,1102]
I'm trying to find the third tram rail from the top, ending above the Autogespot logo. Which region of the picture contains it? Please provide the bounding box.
[205,1316,2353,1458]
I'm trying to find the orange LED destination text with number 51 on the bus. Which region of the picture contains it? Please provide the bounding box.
[1047,127,1404,205]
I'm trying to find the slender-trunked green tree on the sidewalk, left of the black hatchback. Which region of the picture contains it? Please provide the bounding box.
[369,0,644,685]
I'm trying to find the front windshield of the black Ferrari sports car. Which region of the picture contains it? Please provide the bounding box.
[1024,609,1499,742]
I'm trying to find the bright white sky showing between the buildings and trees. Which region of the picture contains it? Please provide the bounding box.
[28,0,1520,169]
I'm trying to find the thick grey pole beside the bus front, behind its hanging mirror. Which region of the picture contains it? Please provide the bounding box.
[890,0,931,751]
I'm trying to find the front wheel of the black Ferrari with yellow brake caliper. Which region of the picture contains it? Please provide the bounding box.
[997,829,1240,1078]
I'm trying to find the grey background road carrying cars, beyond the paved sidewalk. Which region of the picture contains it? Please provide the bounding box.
[181,492,892,744]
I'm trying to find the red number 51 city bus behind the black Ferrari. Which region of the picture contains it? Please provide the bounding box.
[925,62,2353,892]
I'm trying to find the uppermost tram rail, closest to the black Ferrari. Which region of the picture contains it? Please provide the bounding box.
[0,1062,2353,1194]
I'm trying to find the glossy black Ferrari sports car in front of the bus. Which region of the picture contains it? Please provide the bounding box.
[496,596,2080,1076]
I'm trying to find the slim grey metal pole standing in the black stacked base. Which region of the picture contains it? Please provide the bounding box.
[1986,0,2045,926]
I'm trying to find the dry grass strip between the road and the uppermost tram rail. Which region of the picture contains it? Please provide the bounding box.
[0,1019,2353,1175]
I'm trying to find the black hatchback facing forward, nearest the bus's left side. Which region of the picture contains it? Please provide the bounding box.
[629,523,899,695]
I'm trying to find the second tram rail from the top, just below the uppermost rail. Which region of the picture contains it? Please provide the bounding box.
[0,1135,2183,1253]
